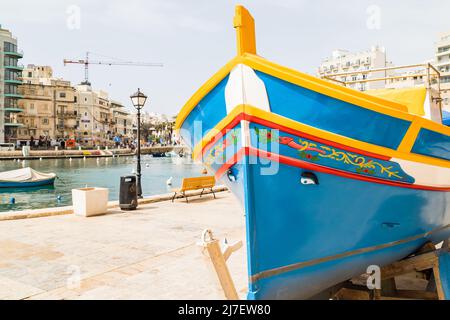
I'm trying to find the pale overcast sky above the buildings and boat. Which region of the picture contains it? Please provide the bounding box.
[0,0,450,115]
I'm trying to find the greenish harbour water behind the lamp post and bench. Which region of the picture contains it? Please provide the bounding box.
[0,156,202,212]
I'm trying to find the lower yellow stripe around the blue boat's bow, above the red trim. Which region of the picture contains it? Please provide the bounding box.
[192,105,450,168]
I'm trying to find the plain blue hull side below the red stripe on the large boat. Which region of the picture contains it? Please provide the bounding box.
[239,153,450,299]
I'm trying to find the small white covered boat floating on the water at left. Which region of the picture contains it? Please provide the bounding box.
[0,167,56,188]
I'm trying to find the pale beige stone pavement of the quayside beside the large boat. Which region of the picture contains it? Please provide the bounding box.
[0,191,247,299]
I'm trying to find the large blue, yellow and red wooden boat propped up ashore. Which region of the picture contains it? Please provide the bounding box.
[176,6,450,299]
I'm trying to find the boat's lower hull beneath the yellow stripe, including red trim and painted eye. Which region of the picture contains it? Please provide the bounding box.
[197,117,450,299]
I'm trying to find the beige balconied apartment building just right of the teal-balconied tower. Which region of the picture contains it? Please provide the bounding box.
[17,65,78,142]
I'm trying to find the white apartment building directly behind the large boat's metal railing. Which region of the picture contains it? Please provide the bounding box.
[318,46,392,91]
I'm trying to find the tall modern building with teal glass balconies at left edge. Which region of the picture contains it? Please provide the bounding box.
[0,26,23,143]
